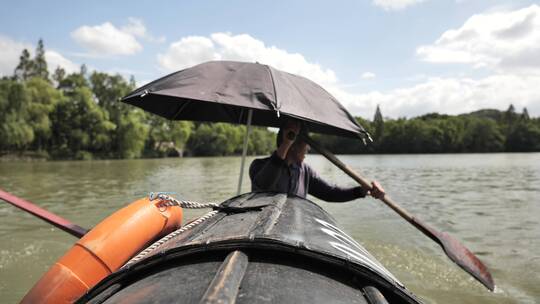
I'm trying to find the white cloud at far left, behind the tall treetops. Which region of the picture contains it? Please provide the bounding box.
[0,35,79,76]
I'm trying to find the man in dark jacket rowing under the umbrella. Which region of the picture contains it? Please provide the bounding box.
[249,121,384,202]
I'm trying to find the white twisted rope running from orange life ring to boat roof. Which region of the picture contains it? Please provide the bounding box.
[122,194,219,268]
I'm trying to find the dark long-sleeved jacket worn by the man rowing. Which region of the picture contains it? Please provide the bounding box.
[249,152,366,202]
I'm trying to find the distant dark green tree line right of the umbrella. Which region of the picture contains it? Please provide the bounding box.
[314,105,540,154]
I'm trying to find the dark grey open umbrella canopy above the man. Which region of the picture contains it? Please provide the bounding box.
[122,61,369,138]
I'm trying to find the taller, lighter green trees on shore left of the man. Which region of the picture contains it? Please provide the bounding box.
[0,40,275,159]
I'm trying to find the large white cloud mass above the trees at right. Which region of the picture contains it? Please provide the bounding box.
[380,5,540,117]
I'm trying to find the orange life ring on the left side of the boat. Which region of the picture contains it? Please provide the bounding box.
[21,198,182,303]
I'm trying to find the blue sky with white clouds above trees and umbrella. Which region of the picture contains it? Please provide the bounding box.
[0,0,540,119]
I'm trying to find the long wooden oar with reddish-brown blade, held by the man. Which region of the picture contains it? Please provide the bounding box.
[300,134,495,291]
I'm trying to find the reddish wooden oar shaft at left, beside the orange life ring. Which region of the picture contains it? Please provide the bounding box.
[0,189,88,238]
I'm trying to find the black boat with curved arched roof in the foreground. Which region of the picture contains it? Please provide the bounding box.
[77,193,420,303]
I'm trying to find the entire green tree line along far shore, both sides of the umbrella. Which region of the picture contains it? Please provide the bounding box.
[0,40,540,159]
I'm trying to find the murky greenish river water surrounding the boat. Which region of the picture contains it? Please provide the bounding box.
[0,153,540,304]
